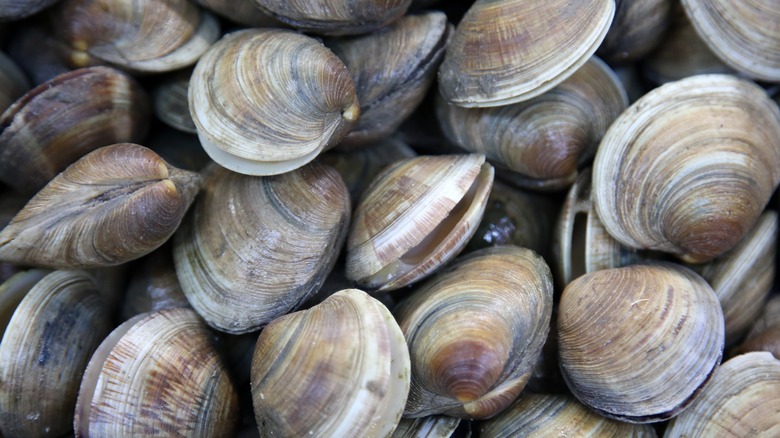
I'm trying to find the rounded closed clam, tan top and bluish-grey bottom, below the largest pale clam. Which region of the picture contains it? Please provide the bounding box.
[558,263,724,423]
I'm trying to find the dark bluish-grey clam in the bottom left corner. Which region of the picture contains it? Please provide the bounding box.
[0,271,111,437]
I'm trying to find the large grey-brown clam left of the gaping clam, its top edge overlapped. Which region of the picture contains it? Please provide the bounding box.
[174,163,351,333]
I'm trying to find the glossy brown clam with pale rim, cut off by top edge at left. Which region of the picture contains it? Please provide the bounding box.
[50,0,220,73]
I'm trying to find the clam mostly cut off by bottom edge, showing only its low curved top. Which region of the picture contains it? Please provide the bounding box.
[479,393,656,438]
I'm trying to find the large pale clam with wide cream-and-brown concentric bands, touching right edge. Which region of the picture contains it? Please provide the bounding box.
[593,75,780,263]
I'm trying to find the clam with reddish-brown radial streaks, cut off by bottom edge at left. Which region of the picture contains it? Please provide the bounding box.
[74,309,238,437]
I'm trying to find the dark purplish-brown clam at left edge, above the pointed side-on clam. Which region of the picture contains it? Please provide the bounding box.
[0,67,149,194]
